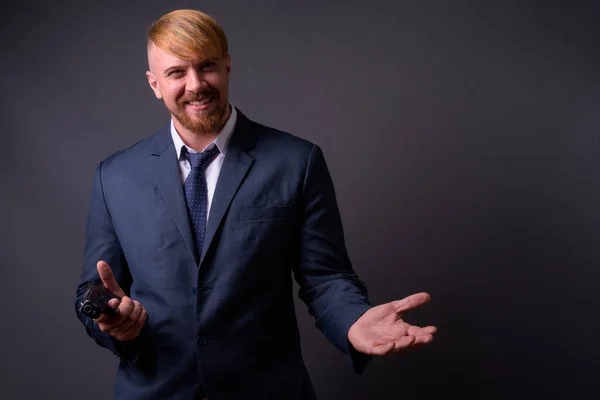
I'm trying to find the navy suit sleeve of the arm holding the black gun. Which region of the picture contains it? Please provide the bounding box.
[75,163,139,362]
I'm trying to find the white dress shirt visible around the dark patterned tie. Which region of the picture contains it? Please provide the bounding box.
[171,105,237,219]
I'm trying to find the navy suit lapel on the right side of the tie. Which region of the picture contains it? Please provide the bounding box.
[199,110,254,266]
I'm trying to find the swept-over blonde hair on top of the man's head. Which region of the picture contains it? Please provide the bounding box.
[147,10,229,60]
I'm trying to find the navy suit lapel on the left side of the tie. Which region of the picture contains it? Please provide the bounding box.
[151,125,198,265]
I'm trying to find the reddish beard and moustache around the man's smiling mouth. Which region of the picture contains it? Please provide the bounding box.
[170,88,228,134]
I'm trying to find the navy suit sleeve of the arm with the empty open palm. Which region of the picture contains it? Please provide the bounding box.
[294,146,371,373]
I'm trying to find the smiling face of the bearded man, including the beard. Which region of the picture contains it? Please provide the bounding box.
[146,41,231,135]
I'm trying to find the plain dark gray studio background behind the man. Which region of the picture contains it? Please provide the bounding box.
[0,0,600,399]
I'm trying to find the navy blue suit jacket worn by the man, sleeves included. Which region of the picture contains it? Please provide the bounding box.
[76,110,370,400]
